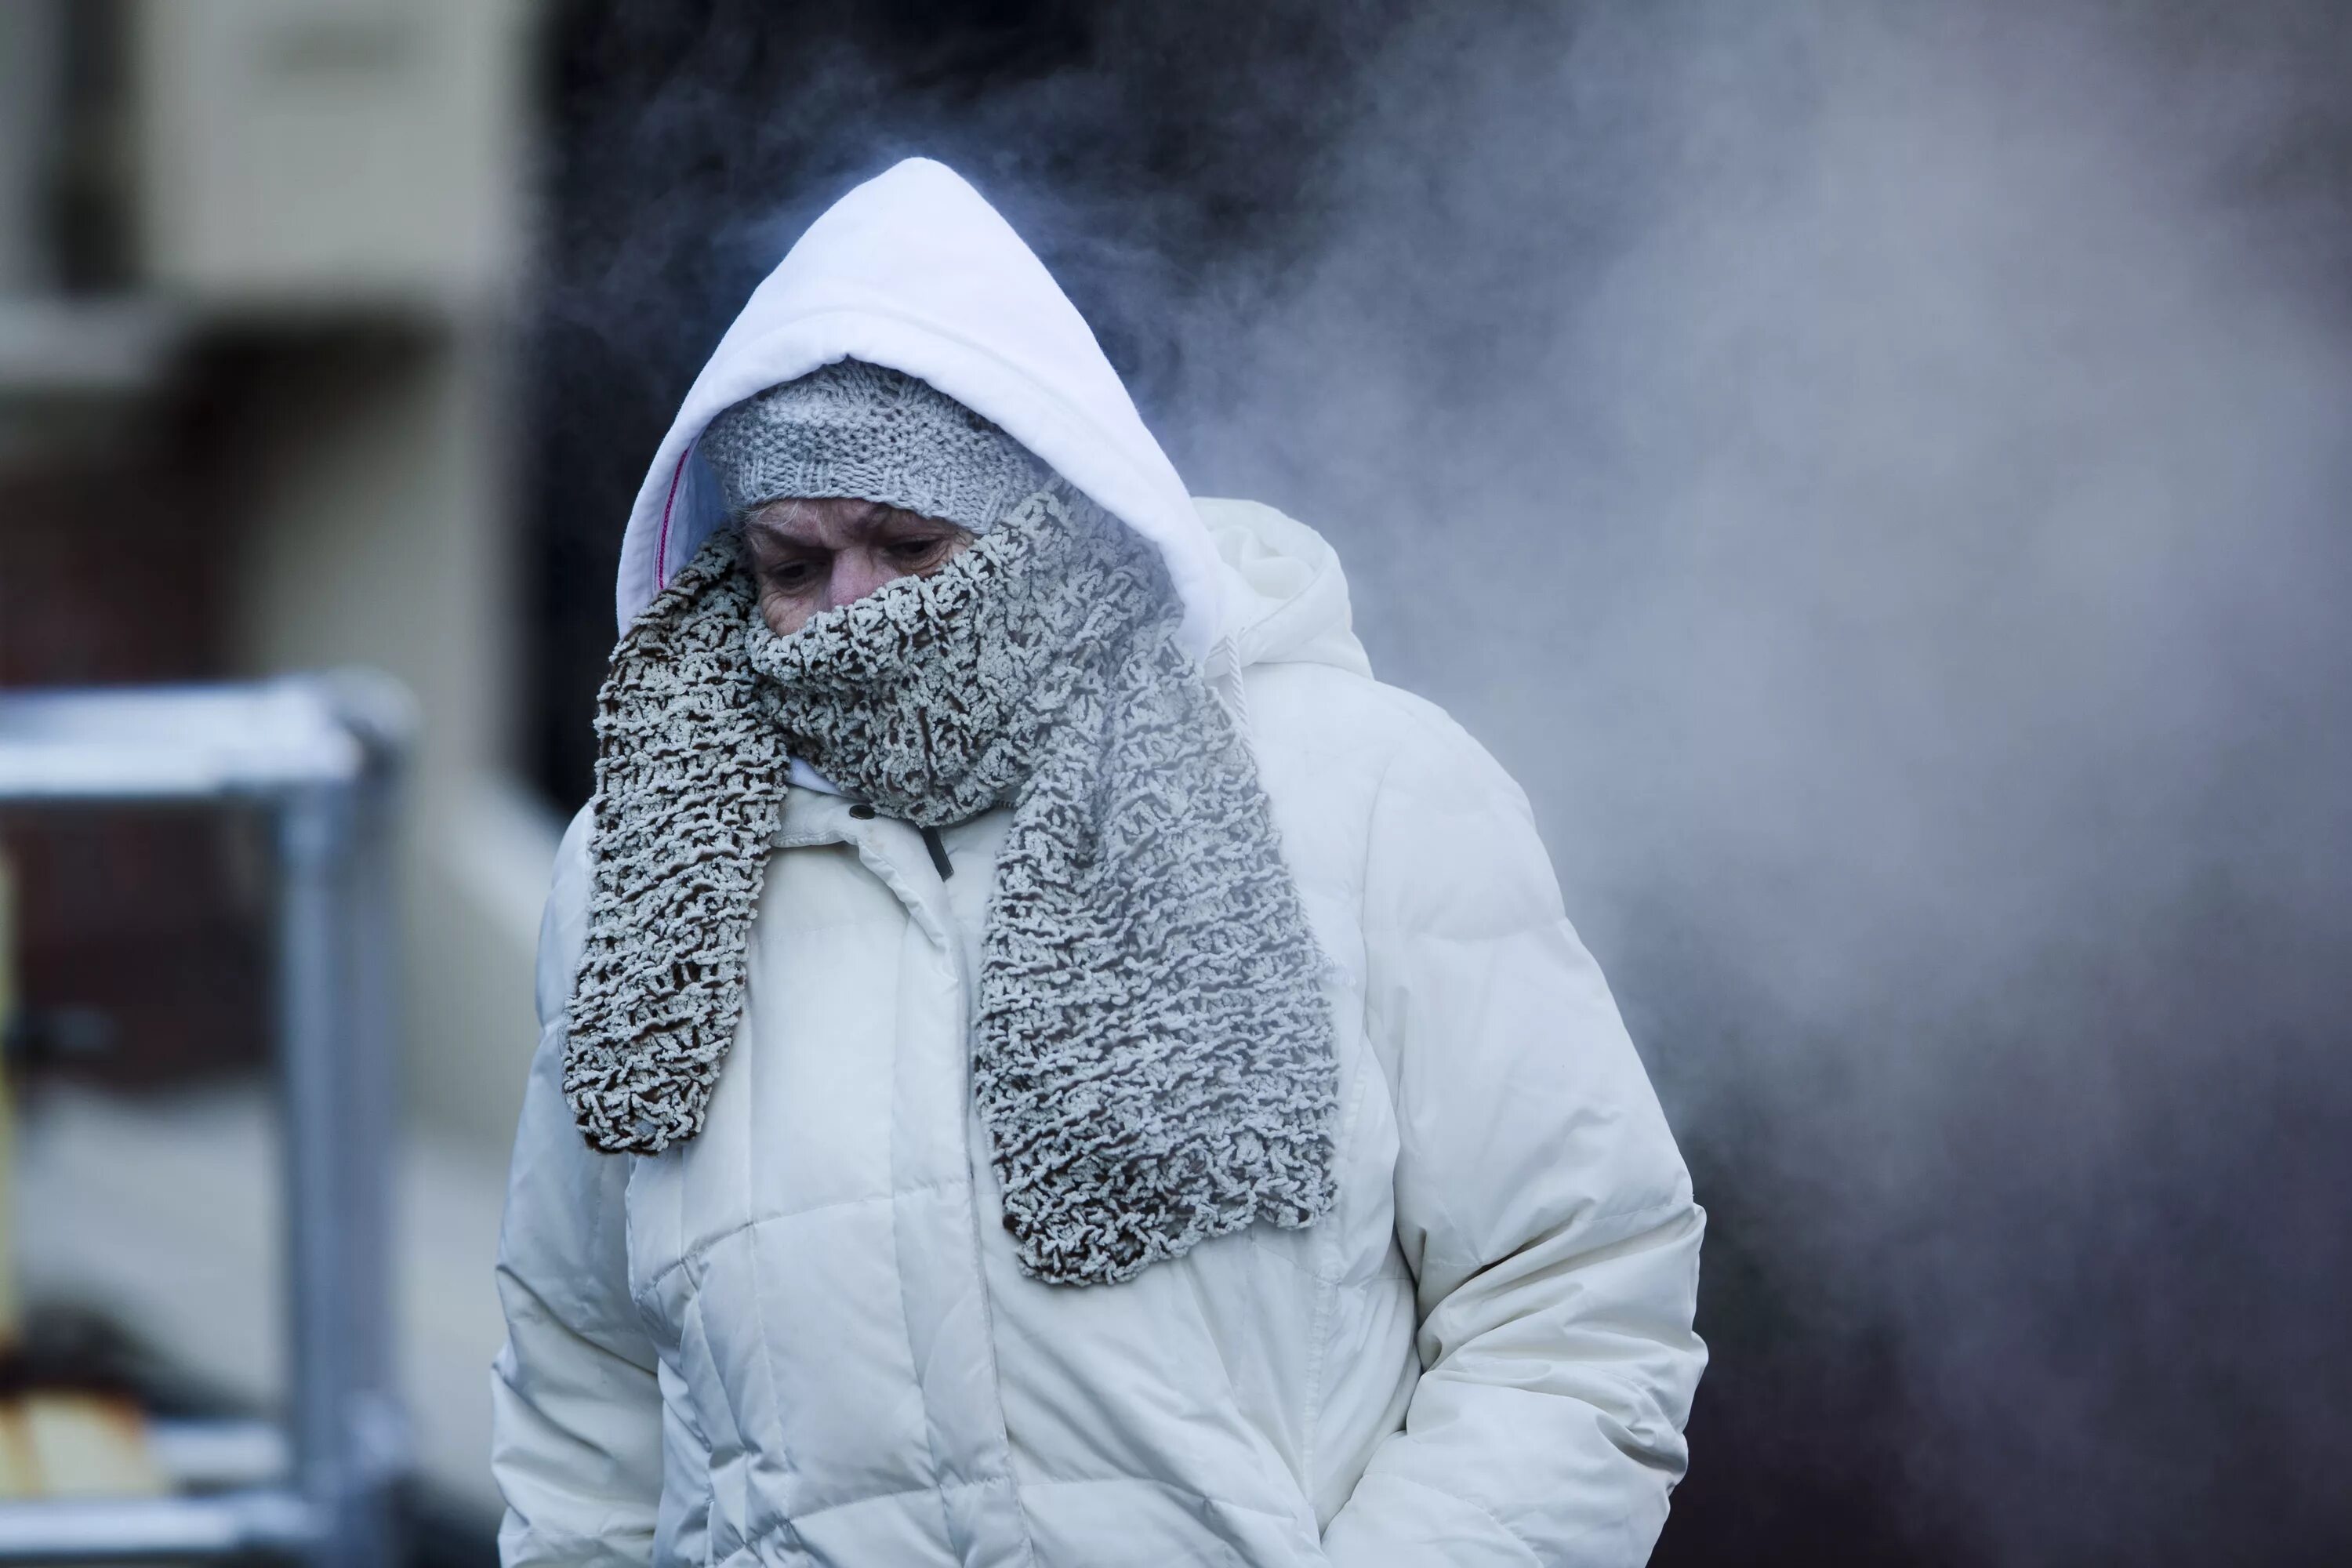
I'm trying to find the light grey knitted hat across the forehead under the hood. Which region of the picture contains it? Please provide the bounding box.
[701,360,1054,534]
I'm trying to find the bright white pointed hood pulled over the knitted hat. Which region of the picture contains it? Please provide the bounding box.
[614,158,1223,661]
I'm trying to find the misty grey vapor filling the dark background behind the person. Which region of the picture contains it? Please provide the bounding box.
[550,0,2352,1563]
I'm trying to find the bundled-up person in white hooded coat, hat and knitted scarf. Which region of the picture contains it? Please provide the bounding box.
[494,162,1705,1568]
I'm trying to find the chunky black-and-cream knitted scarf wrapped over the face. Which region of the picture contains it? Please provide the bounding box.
[564,485,1338,1283]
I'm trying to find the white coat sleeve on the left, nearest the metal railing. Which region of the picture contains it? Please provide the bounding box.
[492,813,661,1568]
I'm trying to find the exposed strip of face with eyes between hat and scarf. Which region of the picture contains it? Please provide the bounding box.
[743,496,971,637]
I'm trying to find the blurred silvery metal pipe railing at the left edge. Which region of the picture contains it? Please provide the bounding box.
[0,675,412,1568]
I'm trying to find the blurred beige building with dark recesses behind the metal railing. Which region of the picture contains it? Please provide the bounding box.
[0,0,541,1535]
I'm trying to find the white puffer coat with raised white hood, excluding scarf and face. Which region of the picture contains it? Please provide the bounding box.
[494,162,1705,1568]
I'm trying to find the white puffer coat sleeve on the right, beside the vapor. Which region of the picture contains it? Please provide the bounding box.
[1324,715,1705,1568]
